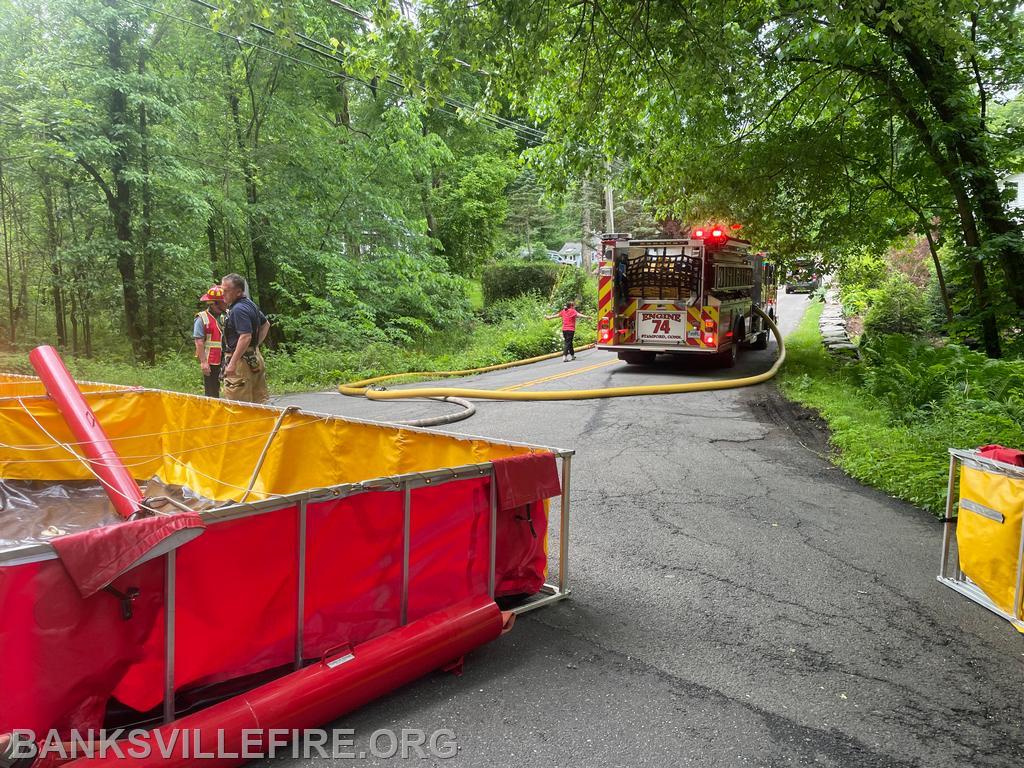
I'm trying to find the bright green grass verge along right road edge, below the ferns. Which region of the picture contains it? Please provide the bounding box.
[779,304,1024,514]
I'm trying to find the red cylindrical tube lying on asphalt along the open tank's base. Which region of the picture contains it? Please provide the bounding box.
[66,597,504,768]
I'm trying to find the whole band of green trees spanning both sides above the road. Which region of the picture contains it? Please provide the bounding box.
[0,0,1024,361]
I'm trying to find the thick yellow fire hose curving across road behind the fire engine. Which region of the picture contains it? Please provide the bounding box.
[338,307,785,400]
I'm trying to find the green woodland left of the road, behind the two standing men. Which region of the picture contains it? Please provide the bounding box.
[0,0,600,382]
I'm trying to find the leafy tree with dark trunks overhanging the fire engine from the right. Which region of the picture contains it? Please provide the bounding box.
[421,0,1024,356]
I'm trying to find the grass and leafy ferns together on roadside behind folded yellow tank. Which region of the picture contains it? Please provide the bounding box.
[781,304,1024,514]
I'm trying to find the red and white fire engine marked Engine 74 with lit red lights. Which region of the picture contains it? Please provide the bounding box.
[597,226,777,367]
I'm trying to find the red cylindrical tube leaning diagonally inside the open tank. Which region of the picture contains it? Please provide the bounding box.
[29,345,142,517]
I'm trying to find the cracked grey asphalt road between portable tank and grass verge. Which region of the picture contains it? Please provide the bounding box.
[272,296,1024,768]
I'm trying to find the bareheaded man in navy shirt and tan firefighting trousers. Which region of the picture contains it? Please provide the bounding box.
[220,272,270,402]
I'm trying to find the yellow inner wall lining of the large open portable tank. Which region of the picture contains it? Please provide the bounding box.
[0,375,532,502]
